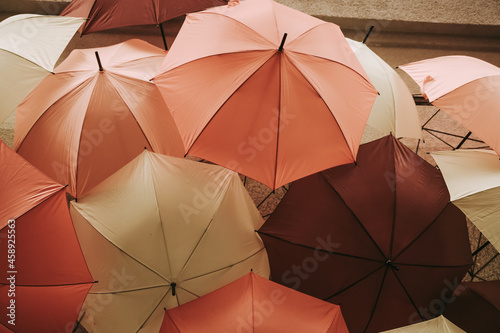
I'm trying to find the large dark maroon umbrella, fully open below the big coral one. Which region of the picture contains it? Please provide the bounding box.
[259,136,472,333]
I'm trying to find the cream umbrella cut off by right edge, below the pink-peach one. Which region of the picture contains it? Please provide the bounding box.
[432,150,500,251]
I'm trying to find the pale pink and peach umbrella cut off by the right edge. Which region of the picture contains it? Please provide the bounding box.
[399,56,500,154]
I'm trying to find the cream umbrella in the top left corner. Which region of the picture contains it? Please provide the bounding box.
[0,14,84,123]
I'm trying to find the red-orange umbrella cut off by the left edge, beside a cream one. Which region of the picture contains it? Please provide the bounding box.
[0,140,94,333]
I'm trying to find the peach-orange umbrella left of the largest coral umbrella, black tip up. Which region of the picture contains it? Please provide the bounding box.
[14,40,184,198]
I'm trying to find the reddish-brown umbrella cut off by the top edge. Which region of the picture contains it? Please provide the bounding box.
[61,0,227,34]
